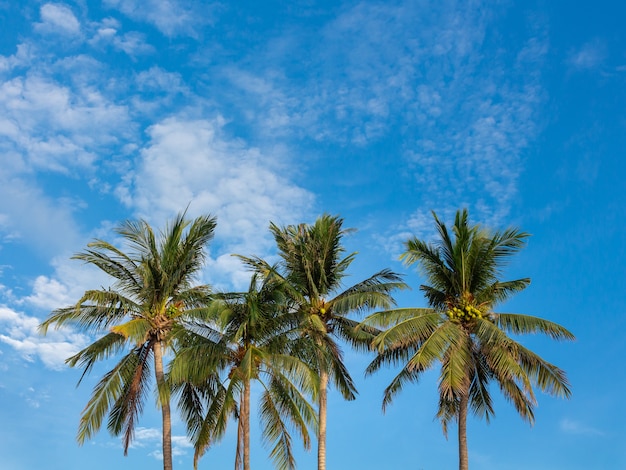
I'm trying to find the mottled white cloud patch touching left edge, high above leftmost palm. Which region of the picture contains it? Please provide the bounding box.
[0,75,130,172]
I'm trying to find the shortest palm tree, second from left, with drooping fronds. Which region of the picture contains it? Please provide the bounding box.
[171,274,318,470]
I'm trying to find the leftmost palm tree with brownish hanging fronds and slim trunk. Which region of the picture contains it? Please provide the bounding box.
[40,213,215,470]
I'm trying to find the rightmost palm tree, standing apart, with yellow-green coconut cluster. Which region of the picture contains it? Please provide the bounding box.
[363,210,574,470]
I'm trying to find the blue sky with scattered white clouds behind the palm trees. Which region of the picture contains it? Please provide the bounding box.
[0,0,626,470]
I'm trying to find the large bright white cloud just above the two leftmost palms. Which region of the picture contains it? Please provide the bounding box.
[118,118,312,288]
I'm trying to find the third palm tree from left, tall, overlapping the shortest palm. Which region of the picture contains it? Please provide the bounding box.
[241,215,406,470]
